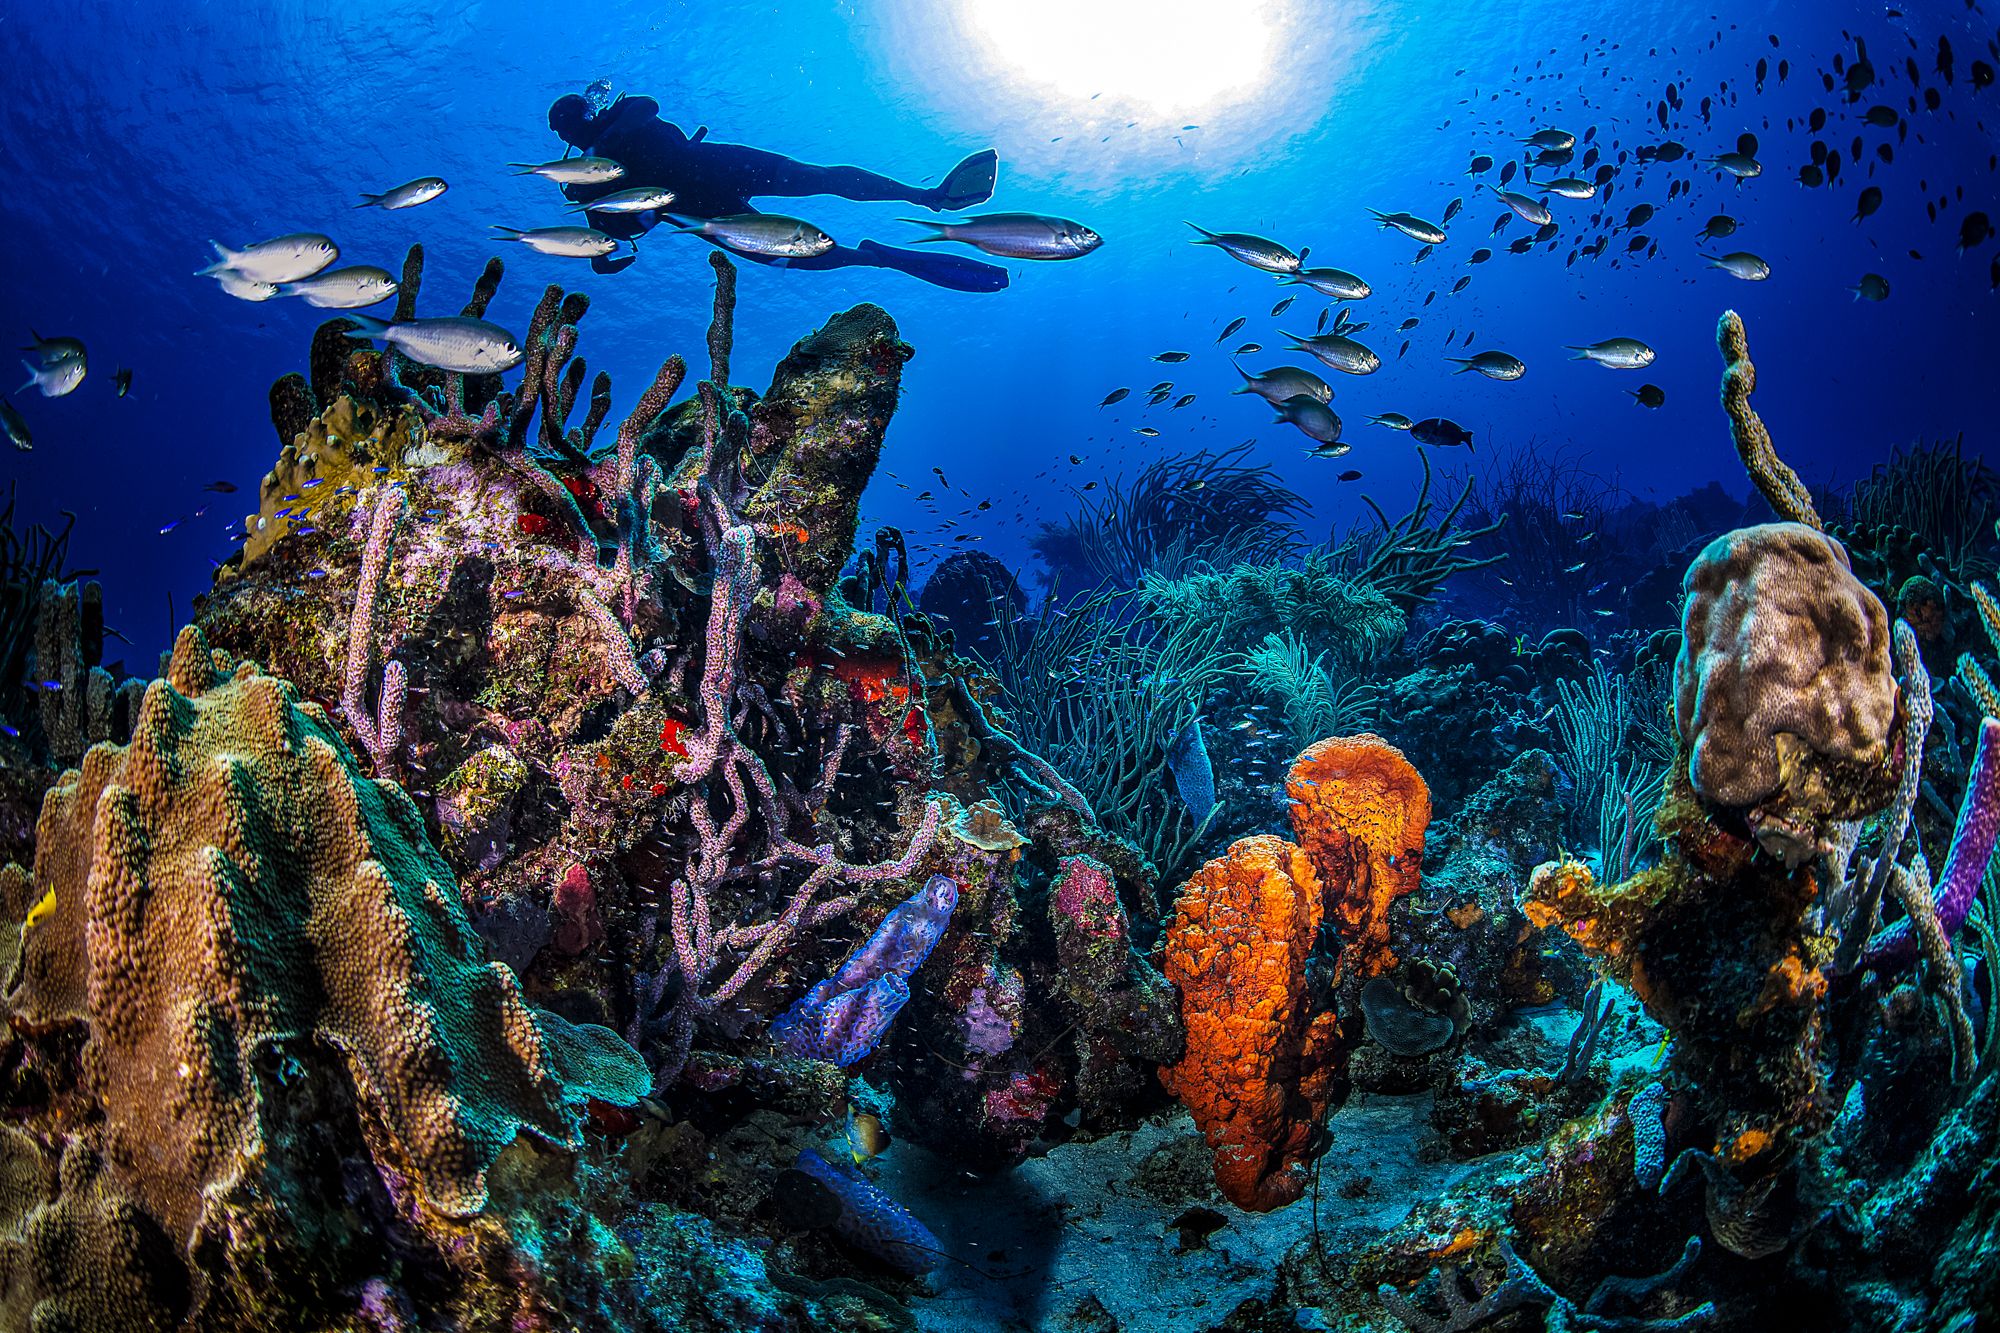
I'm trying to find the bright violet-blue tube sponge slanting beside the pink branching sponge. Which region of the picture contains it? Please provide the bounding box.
[770,875,958,1065]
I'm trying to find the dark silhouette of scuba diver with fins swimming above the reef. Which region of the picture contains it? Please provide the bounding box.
[548,92,1008,292]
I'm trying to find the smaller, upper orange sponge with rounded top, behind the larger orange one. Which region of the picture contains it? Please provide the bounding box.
[1284,733,1430,979]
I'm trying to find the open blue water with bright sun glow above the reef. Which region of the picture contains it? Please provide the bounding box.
[0,0,2000,660]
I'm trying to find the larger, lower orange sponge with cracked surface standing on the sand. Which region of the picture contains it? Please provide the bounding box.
[1160,836,1344,1213]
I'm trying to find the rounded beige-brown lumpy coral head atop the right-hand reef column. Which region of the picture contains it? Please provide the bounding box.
[1674,522,1896,807]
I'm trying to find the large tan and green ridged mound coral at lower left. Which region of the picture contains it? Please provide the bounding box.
[6,628,646,1243]
